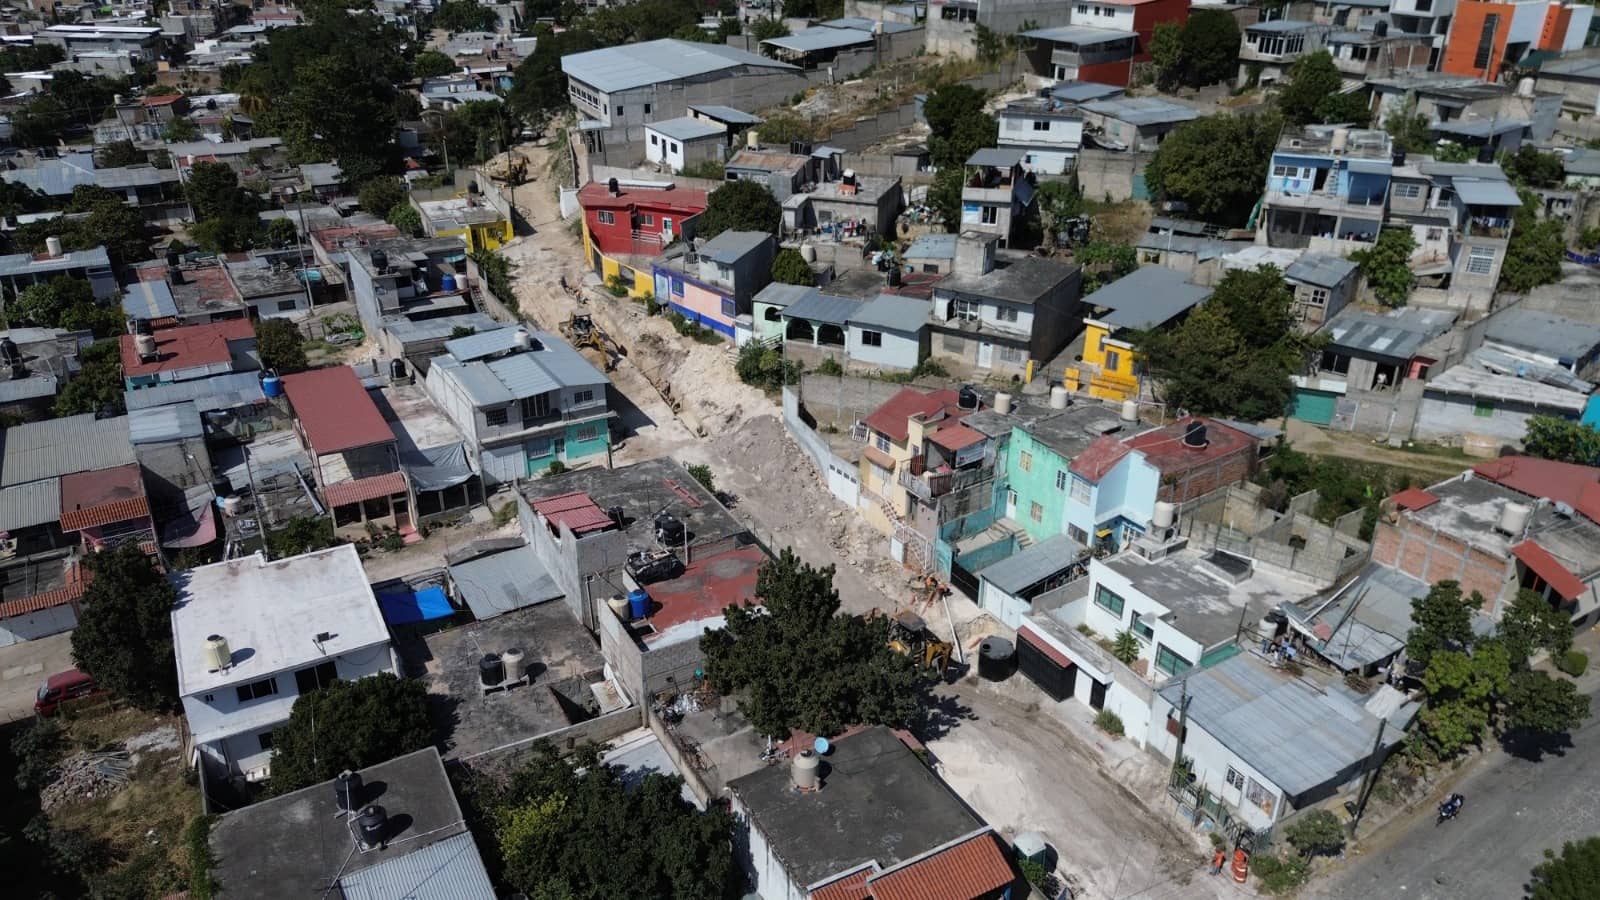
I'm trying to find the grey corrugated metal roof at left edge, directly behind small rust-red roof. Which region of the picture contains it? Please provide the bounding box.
[0,413,134,485]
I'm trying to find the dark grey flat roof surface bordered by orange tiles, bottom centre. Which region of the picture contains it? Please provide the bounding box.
[728,727,982,886]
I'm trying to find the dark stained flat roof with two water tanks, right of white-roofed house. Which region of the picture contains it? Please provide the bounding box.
[395,604,605,759]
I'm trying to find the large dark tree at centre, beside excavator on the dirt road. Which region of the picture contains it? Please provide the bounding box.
[701,548,918,738]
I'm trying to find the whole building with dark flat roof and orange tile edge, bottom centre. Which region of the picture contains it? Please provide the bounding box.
[728,725,1018,900]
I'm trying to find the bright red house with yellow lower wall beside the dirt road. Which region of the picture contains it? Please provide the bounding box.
[578,179,706,296]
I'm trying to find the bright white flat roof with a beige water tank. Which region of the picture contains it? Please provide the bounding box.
[173,544,389,697]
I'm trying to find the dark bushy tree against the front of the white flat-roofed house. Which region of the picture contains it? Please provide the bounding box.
[267,673,434,794]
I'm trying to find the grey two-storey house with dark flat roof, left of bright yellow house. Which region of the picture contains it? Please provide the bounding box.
[928,231,1083,380]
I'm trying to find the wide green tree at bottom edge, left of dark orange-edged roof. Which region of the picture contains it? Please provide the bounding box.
[480,741,742,900]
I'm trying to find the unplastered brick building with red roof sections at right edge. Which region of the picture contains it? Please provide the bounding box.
[1373,456,1600,626]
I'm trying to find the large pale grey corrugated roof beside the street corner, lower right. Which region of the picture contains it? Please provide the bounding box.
[1160,653,1405,798]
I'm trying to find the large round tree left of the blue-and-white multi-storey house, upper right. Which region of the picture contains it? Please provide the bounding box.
[1144,114,1282,224]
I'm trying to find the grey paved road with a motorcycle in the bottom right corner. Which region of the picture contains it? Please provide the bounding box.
[1307,703,1600,900]
